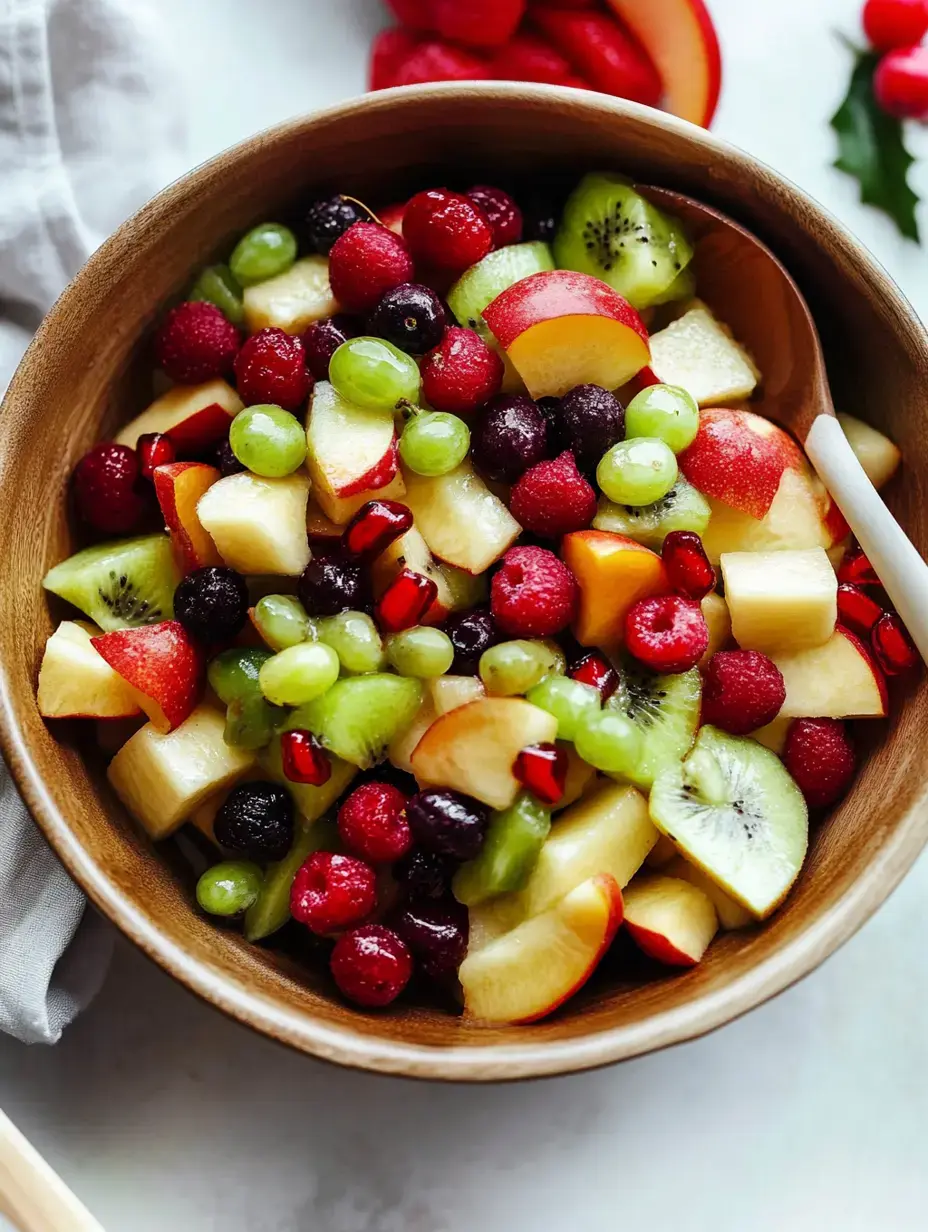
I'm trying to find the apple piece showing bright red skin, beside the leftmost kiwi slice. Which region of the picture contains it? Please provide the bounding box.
[90,620,205,732]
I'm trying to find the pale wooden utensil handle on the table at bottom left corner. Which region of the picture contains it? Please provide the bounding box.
[0,1112,104,1232]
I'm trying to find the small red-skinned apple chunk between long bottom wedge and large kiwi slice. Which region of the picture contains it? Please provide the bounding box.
[625,873,718,967]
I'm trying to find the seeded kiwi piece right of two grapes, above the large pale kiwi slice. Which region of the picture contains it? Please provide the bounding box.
[605,664,702,790]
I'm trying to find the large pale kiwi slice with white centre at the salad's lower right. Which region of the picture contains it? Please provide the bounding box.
[651,727,808,919]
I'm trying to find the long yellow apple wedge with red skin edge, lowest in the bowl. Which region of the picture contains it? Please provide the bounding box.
[458,875,622,1023]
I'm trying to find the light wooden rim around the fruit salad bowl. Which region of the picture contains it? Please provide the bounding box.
[0,83,928,1082]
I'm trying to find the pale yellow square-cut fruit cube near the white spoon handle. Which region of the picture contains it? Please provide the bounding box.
[721,547,838,653]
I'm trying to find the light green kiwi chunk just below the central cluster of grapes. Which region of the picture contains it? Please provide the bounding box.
[288,673,423,770]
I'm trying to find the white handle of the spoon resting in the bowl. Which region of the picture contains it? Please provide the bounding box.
[806,415,928,663]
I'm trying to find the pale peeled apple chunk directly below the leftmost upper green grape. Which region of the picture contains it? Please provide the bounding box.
[196,471,309,577]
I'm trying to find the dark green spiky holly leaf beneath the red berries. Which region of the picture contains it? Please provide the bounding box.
[832,52,918,241]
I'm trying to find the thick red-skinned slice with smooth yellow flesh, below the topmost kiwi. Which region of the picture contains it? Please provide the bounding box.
[483,270,649,398]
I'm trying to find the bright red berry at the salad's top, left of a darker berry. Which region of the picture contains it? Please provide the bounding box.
[403,188,493,274]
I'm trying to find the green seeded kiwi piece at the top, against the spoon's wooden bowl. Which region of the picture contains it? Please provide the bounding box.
[555,171,693,308]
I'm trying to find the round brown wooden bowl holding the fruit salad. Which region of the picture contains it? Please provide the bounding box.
[0,85,928,1082]
